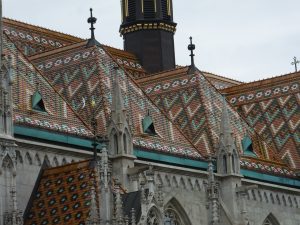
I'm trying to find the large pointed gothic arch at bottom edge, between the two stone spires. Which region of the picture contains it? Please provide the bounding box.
[164,198,191,225]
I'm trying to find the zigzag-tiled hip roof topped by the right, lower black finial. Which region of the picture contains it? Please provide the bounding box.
[138,68,276,160]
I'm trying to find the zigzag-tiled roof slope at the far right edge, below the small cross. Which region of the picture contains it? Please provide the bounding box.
[222,72,300,168]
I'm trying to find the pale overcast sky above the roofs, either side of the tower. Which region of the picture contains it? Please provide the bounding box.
[3,0,300,81]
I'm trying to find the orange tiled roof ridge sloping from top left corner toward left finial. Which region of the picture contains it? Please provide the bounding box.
[3,17,83,41]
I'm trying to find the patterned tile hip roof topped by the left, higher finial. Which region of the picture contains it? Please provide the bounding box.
[30,42,201,158]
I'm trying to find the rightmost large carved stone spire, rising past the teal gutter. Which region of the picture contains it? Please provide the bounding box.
[217,97,240,175]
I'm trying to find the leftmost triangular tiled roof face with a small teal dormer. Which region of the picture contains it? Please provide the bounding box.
[3,36,92,137]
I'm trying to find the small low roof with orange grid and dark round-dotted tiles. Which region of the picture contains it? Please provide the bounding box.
[24,160,98,225]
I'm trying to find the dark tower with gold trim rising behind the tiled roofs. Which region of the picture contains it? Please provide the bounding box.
[120,0,176,73]
